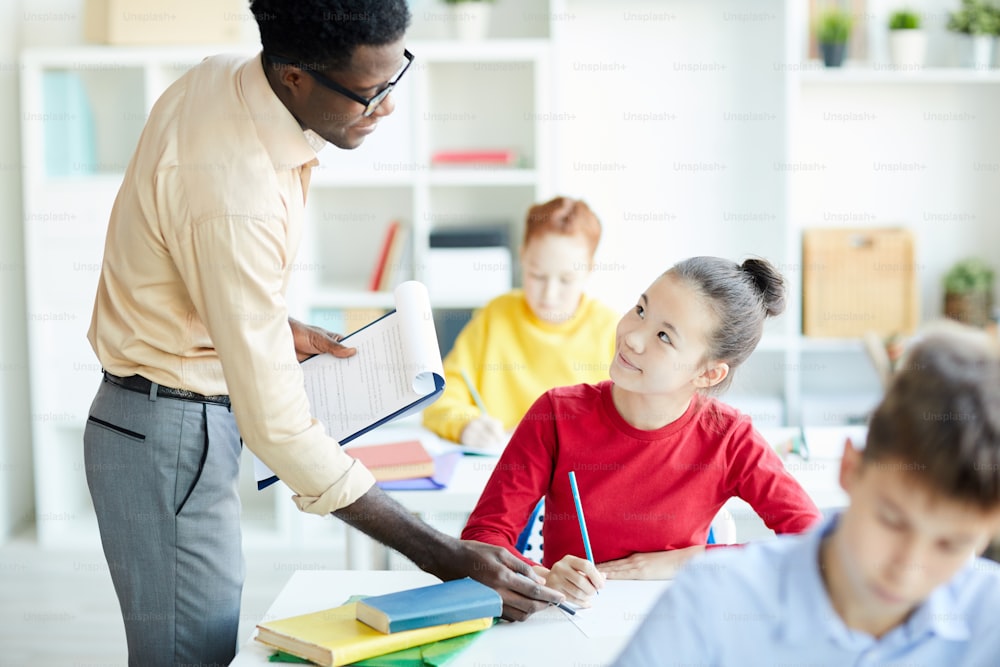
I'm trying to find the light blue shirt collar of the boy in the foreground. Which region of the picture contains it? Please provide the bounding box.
[779,513,973,646]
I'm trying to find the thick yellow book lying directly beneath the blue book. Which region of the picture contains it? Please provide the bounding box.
[255,602,493,667]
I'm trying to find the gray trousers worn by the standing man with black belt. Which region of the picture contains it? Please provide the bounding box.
[84,380,244,667]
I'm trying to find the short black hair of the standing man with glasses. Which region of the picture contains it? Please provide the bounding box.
[250,0,410,70]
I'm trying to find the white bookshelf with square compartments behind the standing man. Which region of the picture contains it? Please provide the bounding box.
[21,3,552,547]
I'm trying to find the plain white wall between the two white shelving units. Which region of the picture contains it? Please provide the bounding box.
[552,0,786,316]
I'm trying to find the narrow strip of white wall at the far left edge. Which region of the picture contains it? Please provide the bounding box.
[0,0,34,539]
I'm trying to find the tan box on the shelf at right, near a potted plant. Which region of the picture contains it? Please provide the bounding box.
[802,228,919,338]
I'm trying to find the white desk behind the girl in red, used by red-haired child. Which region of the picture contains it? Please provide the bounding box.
[347,425,865,570]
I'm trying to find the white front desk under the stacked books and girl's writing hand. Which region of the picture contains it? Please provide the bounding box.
[231,570,669,667]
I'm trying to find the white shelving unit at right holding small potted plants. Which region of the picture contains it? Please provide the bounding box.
[785,0,1000,426]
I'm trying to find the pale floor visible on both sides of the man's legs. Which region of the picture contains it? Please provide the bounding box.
[0,535,345,667]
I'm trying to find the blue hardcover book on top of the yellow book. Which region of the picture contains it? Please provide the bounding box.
[357,577,503,634]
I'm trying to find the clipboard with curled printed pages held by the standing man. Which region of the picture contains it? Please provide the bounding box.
[254,280,444,489]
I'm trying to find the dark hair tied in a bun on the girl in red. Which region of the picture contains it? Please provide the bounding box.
[667,257,785,392]
